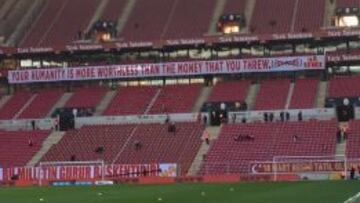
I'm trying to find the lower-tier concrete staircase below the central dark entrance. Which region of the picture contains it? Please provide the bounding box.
[187,126,221,176]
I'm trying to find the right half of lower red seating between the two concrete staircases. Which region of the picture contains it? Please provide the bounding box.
[116,122,203,175]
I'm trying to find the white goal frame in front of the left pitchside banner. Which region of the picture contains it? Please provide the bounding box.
[37,160,105,186]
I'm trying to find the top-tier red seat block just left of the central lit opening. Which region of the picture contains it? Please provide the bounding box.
[164,0,215,39]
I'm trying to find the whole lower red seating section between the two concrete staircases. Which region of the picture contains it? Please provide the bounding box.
[42,123,203,174]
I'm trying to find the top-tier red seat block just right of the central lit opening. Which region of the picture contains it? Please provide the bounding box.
[249,0,295,34]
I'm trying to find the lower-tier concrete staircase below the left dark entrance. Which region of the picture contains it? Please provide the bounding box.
[26,131,65,167]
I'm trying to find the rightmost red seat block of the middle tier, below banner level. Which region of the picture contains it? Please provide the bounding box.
[328,76,360,97]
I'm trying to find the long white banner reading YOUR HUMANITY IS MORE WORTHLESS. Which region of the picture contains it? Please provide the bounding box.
[8,55,325,84]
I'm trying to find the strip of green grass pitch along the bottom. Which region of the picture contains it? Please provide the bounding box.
[0,181,360,203]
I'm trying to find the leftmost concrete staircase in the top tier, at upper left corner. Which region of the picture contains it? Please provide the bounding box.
[6,0,48,46]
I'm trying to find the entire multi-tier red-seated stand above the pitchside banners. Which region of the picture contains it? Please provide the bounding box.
[0,0,360,186]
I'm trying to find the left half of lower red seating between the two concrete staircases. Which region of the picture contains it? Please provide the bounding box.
[42,125,135,163]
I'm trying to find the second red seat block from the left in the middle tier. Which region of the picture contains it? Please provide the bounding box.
[18,89,64,119]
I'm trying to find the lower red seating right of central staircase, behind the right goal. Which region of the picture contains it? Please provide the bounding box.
[199,121,337,174]
